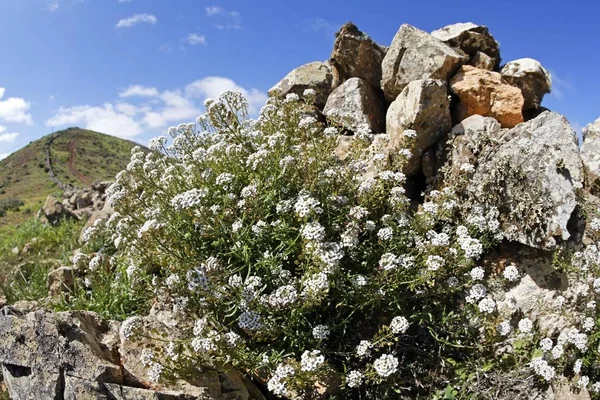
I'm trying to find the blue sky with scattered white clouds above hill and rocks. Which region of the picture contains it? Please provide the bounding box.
[0,0,600,158]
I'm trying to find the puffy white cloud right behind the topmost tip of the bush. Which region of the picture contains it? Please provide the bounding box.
[185,76,267,114]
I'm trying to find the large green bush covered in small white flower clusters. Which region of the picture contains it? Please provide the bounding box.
[77,91,600,399]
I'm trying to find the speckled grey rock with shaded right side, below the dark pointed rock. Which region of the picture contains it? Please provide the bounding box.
[323,78,385,133]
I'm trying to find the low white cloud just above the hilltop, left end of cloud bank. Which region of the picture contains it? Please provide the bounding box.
[46,103,143,137]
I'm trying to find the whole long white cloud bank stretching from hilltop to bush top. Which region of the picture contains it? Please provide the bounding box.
[46,76,267,138]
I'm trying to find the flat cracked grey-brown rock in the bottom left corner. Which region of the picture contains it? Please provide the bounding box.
[0,311,121,399]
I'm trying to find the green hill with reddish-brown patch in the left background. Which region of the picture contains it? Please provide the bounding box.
[0,128,136,226]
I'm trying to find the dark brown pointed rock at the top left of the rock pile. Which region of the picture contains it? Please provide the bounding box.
[329,22,385,88]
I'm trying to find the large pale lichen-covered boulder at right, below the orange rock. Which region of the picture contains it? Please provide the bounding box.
[469,111,583,250]
